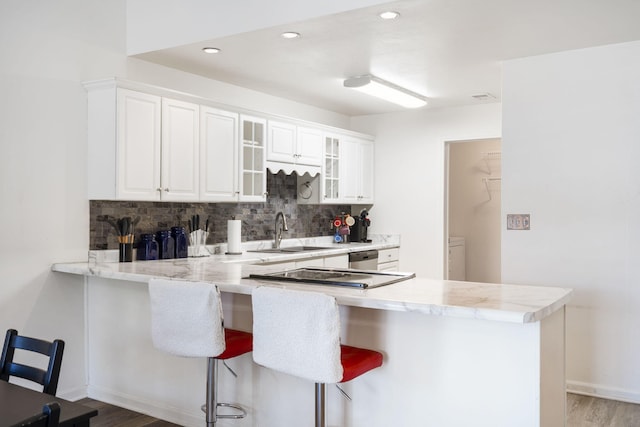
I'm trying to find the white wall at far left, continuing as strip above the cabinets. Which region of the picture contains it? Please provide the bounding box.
[0,0,348,399]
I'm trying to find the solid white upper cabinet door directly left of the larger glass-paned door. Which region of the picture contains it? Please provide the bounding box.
[200,106,239,202]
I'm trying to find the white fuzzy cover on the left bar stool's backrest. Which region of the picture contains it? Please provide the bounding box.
[149,279,225,357]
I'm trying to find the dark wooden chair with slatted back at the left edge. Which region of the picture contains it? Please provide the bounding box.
[0,329,64,396]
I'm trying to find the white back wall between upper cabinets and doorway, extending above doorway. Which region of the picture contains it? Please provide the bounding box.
[352,103,501,279]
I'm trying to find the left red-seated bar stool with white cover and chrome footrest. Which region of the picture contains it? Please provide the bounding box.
[149,279,253,427]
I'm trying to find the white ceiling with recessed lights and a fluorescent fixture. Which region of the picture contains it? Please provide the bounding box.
[136,0,640,116]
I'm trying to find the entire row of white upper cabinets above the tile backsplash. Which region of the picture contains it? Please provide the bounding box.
[85,78,373,204]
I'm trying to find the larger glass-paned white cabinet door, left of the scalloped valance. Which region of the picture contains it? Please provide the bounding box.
[239,115,267,202]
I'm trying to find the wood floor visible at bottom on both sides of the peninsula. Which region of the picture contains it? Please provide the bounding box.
[78,394,640,427]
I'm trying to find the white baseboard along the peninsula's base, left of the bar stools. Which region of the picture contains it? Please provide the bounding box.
[88,386,204,427]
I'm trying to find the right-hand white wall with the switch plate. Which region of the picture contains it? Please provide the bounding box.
[502,42,640,402]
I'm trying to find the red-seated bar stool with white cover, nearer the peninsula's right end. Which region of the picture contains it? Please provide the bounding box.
[251,286,382,427]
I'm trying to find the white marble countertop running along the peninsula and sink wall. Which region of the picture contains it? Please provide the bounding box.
[52,234,572,323]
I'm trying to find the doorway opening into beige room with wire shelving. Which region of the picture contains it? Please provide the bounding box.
[444,138,502,283]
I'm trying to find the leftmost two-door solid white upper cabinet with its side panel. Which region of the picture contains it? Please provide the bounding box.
[87,80,199,201]
